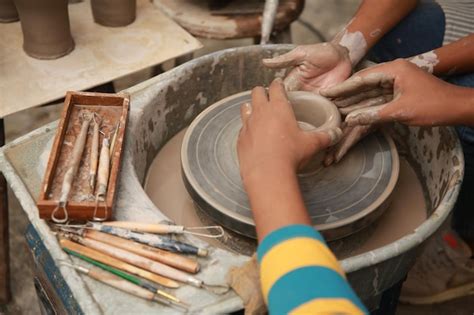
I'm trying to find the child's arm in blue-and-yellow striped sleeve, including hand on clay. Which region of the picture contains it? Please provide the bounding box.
[237,79,368,314]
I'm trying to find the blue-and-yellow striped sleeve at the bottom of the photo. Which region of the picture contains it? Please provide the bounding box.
[257,225,368,315]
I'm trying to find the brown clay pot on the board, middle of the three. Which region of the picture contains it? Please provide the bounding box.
[15,0,74,59]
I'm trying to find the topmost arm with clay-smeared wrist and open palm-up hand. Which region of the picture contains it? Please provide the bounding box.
[263,0,417,93]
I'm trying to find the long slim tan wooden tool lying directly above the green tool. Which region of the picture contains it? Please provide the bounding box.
[68,235,207,288]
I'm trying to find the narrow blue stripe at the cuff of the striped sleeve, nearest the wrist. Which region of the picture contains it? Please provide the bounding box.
[257,224,326,263]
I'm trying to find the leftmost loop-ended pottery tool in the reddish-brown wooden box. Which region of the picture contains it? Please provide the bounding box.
[51,111,92,223]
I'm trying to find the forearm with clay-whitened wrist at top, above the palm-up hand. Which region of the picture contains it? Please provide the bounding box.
[333,0,418,65]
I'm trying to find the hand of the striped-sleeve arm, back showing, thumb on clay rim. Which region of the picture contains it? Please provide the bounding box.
[237,79,342,183]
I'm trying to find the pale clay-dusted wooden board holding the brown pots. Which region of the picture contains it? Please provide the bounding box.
[0,0,202,117]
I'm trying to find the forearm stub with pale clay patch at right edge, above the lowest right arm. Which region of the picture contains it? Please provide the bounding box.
[409,34,474,75]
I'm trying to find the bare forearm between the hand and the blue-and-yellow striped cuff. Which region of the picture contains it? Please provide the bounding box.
[244,162,311,241]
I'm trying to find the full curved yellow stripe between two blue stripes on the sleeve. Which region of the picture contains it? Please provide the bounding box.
[260,237,345,302]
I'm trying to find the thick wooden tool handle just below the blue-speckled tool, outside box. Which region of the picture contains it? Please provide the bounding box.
[82,229,199,273]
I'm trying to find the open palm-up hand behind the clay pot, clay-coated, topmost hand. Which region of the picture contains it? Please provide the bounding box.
[263,43,352,92]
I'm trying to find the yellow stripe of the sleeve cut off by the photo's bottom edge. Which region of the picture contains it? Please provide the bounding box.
[290,298,364,315]
